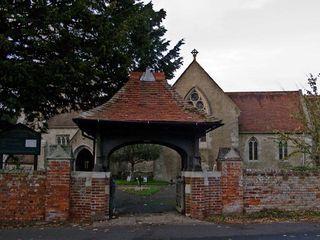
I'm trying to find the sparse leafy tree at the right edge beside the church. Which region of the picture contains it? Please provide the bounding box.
[278,74,320,167]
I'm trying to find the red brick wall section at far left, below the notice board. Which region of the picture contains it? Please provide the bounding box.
[0,171,46,222]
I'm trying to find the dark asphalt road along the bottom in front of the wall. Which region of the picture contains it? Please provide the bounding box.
[0,222,320,240]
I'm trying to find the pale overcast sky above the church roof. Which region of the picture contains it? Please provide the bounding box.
[145,0,320,91]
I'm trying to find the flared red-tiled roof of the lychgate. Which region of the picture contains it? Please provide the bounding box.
[79,72,217,122]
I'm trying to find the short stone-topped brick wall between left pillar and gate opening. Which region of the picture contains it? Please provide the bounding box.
[70,172,110,221]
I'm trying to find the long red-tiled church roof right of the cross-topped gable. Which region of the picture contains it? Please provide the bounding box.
[226,91,303,133]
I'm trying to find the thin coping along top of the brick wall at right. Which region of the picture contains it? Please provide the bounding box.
[243,169,320,176]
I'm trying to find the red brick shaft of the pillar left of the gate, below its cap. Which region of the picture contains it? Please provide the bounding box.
[45,159,70,221]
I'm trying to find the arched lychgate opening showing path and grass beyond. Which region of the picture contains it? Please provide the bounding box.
[110,144,184,216]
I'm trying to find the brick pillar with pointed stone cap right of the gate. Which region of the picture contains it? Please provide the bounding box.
[218,148,243,214]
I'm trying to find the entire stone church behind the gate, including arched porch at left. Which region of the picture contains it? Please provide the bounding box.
[6,51,306,179]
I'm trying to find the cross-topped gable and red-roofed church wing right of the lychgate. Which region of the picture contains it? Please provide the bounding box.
[156,51,307,178]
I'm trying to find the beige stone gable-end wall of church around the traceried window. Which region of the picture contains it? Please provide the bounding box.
[173,62,239,168]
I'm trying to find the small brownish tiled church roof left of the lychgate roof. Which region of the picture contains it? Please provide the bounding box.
[48,112,79,129]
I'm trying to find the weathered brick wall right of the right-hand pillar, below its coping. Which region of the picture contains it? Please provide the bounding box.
[243,170,320,212]
